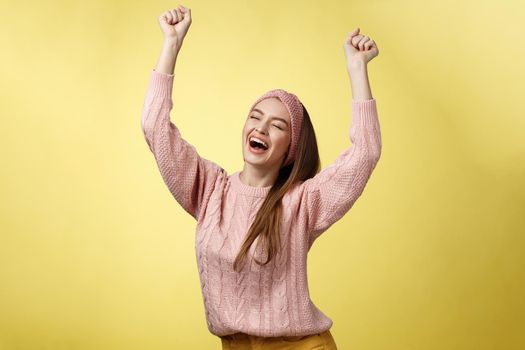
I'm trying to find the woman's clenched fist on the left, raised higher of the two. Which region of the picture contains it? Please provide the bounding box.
[159,5,191,46]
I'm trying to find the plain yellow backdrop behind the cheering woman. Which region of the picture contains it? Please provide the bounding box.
[0,0,525,350]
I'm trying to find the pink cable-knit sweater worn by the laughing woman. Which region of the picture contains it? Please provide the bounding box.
[142,70,381,337]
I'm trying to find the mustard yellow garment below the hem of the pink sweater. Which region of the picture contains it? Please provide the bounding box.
[220,330,337,350]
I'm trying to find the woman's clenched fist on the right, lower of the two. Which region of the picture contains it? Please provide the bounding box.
[343,27,379,69]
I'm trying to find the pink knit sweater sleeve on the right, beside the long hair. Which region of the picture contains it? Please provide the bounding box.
[299,99,381,245]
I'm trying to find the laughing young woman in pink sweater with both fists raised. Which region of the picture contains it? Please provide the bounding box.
[142,6,381,349]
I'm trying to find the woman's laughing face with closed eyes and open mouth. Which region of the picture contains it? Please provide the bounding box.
[242,97,291,168]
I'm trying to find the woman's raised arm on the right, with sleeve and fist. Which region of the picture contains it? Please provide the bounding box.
[299,30,381,245]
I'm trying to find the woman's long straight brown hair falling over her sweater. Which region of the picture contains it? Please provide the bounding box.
[233,105,321,271]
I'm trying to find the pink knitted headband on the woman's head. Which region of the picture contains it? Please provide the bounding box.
[250,89,303,166]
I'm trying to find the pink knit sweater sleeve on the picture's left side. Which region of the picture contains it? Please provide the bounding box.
[141,69,225,220]
